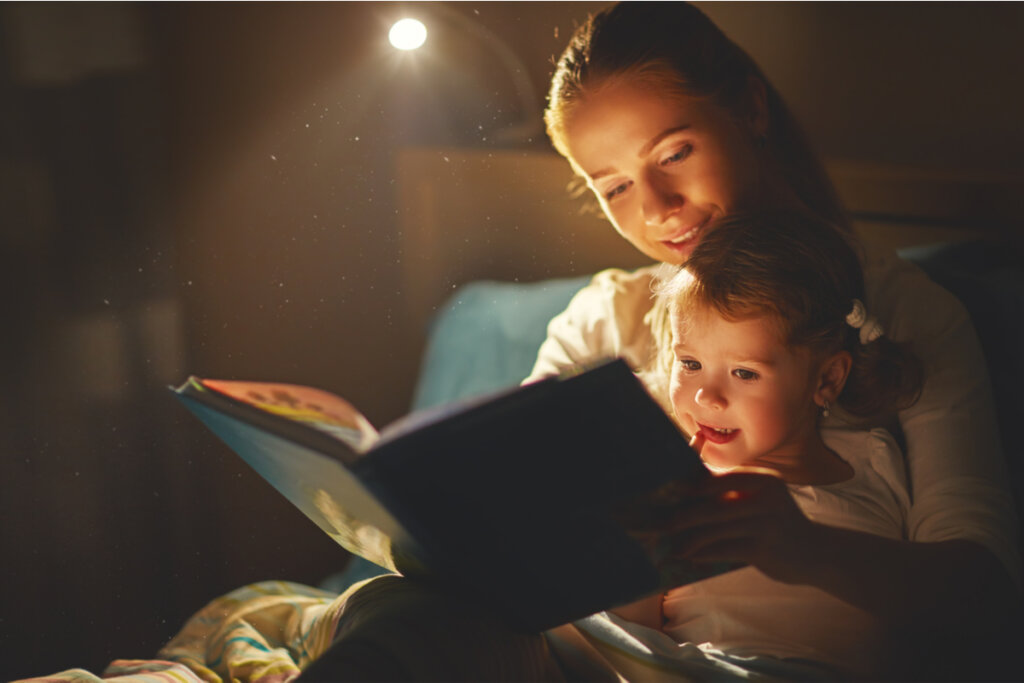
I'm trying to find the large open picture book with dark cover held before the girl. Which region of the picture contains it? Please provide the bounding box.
[176,359,731,631]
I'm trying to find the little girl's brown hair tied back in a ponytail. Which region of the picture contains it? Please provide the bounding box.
[655,212,923,417]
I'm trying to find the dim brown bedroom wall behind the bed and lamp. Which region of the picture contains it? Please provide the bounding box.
[0,2,1024,680]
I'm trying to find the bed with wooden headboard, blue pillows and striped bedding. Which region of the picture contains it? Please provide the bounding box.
[22,147,1024,683]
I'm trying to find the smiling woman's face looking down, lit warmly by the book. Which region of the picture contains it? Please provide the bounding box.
[565,79,761,264]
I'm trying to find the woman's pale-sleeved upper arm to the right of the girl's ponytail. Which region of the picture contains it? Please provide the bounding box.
[864,249,1021,584]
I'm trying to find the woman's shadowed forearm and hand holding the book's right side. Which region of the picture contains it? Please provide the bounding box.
[674,472,1019,647]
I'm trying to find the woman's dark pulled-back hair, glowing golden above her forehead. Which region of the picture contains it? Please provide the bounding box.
[544,1,851,229]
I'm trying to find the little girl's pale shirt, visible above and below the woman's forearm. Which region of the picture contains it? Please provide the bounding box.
[664,429,910,676]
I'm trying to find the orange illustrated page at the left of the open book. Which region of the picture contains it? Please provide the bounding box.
[202,379,379,453]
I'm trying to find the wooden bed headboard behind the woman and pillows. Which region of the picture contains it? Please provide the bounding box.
[396,147,1024,330]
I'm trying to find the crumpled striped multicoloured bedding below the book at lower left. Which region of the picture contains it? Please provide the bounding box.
[22,581,364,683]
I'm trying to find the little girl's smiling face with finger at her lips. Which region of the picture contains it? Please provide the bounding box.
[671,311,817,469]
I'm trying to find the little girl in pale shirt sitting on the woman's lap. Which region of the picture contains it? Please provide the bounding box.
[580,212,922,680]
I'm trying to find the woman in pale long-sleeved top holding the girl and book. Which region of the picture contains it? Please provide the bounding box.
[530,2,1020,679]
